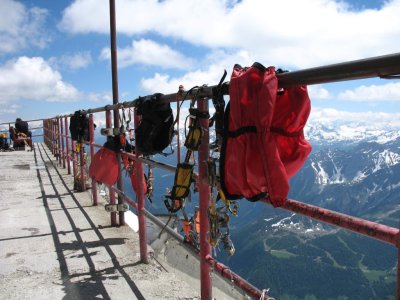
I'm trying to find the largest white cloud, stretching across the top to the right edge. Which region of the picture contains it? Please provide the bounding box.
[60,0,400,68]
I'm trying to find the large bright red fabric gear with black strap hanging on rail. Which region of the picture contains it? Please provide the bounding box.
[220,63,311,206]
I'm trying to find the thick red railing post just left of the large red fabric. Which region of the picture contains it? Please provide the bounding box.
[197,98,212,300]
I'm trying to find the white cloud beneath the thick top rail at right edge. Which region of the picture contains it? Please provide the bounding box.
[338,82,400,102]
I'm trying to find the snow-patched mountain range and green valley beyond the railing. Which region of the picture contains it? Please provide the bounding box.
[220,125,400,299]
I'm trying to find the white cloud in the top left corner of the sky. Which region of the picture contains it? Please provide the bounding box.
[0,0,50,54]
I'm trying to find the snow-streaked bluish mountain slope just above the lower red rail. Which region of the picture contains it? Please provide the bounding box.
[291,137,400,216]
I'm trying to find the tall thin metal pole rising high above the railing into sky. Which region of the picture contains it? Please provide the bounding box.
[110,0,125,226]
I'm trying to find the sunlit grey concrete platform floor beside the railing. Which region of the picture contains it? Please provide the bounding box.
[0,144,200,299]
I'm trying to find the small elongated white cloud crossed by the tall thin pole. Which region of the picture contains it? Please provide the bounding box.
[100,39,193,69]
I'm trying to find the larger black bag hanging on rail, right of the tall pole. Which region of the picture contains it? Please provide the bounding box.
[136,93,174,156]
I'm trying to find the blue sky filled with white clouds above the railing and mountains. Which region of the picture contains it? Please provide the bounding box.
[0,0,400,128]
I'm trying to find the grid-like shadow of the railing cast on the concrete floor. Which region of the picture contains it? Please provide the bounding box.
[34,145,145,299]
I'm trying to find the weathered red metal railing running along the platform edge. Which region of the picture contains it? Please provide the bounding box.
[38,53,400,299]
